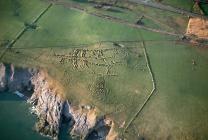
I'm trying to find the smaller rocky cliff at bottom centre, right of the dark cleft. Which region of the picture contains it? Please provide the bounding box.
[64,103,117,140]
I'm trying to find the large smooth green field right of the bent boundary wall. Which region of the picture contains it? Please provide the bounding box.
[126,42,208,140]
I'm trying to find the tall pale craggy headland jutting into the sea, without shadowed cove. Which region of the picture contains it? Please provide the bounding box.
[28,71,64,137]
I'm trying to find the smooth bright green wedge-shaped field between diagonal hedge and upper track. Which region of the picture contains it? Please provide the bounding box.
[14,5,176,48]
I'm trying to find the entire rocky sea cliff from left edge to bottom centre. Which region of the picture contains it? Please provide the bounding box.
[0,63,116,140]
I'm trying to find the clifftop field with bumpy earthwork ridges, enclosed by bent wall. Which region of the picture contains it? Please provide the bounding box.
[3,42,152,128]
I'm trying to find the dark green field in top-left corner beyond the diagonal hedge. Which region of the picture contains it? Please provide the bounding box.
[0,0,48,46]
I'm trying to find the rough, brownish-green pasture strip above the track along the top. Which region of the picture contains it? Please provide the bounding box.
[61,0,188,33]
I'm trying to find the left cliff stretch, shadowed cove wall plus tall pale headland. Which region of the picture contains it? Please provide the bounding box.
[0,63,65,137]
